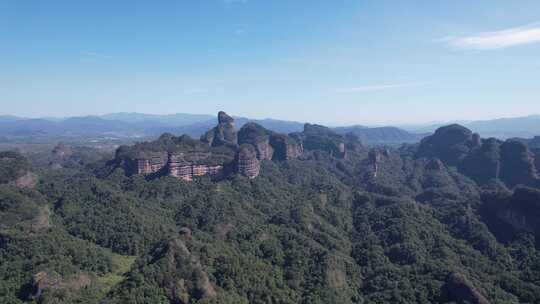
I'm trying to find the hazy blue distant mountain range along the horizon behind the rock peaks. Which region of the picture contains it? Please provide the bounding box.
[0,113,540,145]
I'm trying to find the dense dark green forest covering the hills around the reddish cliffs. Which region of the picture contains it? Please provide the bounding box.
[0,115,540,304]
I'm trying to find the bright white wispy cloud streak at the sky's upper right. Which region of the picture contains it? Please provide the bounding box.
[442,23,540,50]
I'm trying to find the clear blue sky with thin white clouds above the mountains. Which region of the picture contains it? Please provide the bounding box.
[0,0,540,124]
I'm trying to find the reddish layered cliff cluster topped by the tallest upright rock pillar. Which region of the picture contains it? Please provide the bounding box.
[116,112,303,181]
